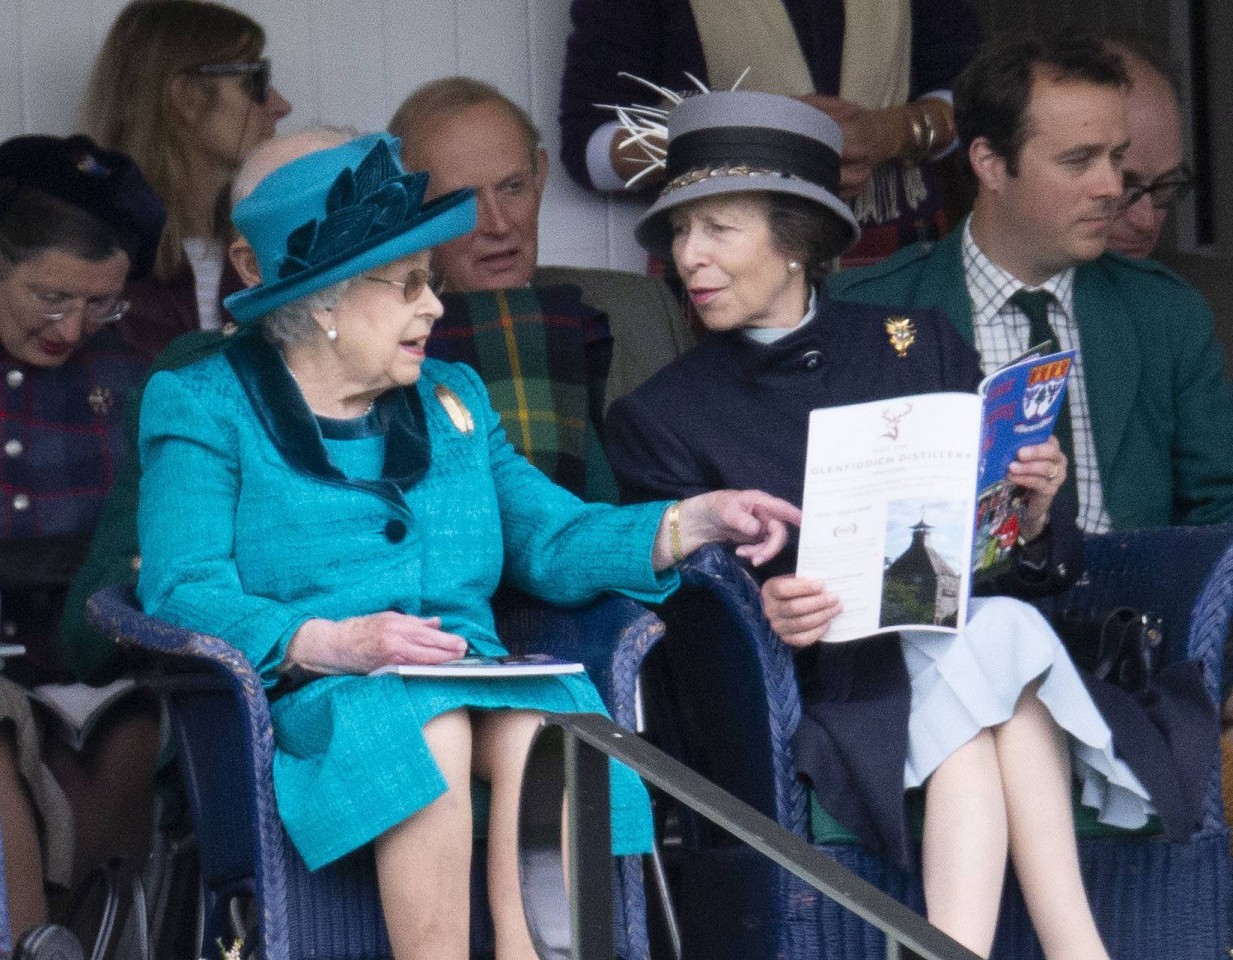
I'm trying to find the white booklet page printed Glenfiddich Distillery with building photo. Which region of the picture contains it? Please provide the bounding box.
[797,393,980,643]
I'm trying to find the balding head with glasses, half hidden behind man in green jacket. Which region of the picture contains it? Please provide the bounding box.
[1108,41,1194,258]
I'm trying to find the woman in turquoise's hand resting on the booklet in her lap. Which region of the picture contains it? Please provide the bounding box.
[285,610,466,673]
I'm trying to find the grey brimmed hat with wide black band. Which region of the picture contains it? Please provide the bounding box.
[634,90,861,255]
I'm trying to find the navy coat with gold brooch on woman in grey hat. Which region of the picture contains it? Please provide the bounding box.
[605,290,1202,866]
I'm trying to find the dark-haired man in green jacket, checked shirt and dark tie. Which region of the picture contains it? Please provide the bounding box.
[830,31,1233,532]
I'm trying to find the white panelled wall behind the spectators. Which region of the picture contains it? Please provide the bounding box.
[0,0,626,269]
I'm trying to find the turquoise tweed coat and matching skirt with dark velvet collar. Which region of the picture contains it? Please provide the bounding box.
[138,336,677,868]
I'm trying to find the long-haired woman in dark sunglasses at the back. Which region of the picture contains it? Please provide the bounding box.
[81,0,291,356]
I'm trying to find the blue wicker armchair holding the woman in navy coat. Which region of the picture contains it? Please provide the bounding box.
[644,527,1233,960]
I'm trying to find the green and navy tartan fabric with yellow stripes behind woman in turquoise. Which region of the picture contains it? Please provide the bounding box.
[428,285,615,500]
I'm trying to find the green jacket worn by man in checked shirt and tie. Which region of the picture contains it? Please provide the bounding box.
[827,229,1233,530]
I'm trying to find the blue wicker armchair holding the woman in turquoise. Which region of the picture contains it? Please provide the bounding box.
[88,588,663,960]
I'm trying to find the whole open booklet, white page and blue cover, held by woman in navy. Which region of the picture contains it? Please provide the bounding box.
[797,342,1074,642]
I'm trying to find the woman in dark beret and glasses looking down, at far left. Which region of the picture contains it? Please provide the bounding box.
[0,136,163,951]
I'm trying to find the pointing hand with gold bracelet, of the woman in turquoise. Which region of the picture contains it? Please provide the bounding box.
[651,490,800,571]
